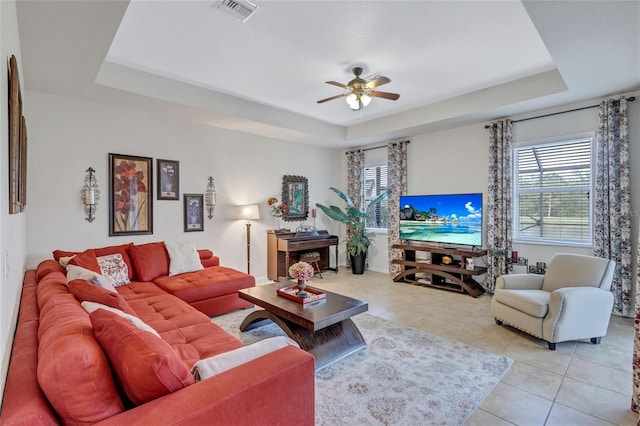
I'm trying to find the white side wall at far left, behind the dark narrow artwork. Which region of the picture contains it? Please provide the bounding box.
[0,0,31,398]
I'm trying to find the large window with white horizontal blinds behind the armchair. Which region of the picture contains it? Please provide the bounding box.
[513,138,593,245]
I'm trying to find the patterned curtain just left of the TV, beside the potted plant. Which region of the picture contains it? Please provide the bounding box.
[387,141,409,275]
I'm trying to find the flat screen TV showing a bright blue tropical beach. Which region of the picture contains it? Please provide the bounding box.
[400,193,482,247]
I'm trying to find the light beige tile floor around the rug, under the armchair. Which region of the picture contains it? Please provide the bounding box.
[298,268,638,426]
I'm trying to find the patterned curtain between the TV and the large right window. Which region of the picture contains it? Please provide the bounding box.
[485,120,512,293]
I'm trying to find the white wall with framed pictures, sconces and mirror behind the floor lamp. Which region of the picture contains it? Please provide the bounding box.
[26,92,340,280]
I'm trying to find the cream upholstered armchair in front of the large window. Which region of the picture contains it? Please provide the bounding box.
[491,253,616,350]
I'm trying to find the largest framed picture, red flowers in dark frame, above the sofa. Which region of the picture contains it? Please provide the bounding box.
[109,154,153,237]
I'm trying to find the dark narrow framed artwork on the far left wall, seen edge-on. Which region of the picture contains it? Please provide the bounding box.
[9,55,26,214]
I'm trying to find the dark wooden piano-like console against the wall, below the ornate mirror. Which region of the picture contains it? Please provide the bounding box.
[267,229,338,281]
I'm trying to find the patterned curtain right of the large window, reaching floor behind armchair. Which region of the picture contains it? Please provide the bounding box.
[593,97,632,316]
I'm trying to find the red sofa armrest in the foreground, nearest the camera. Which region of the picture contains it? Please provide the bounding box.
[99,346,315,426]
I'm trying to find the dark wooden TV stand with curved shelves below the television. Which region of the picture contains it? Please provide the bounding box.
[392,244,487,297]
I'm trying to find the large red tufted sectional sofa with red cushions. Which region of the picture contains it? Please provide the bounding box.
[0,243,315,425]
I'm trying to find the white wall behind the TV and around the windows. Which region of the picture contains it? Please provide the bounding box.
[360,93,640,286]
